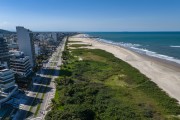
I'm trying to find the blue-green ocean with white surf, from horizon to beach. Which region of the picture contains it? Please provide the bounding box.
[85,32,180,64]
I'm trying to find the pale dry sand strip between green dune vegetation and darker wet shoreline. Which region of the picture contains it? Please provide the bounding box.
[69,34,180,103]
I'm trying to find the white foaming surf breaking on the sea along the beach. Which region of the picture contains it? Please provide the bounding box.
[94,38,180,64]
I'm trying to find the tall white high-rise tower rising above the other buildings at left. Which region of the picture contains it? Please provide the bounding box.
[16,26,35,67]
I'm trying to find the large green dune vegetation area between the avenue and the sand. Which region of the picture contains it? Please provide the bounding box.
[45,39,180,120]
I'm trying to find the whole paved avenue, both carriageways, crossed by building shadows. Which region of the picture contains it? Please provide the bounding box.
[13,38,66,120]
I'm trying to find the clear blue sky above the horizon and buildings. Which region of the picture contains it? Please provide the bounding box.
[0,0,180,32]
